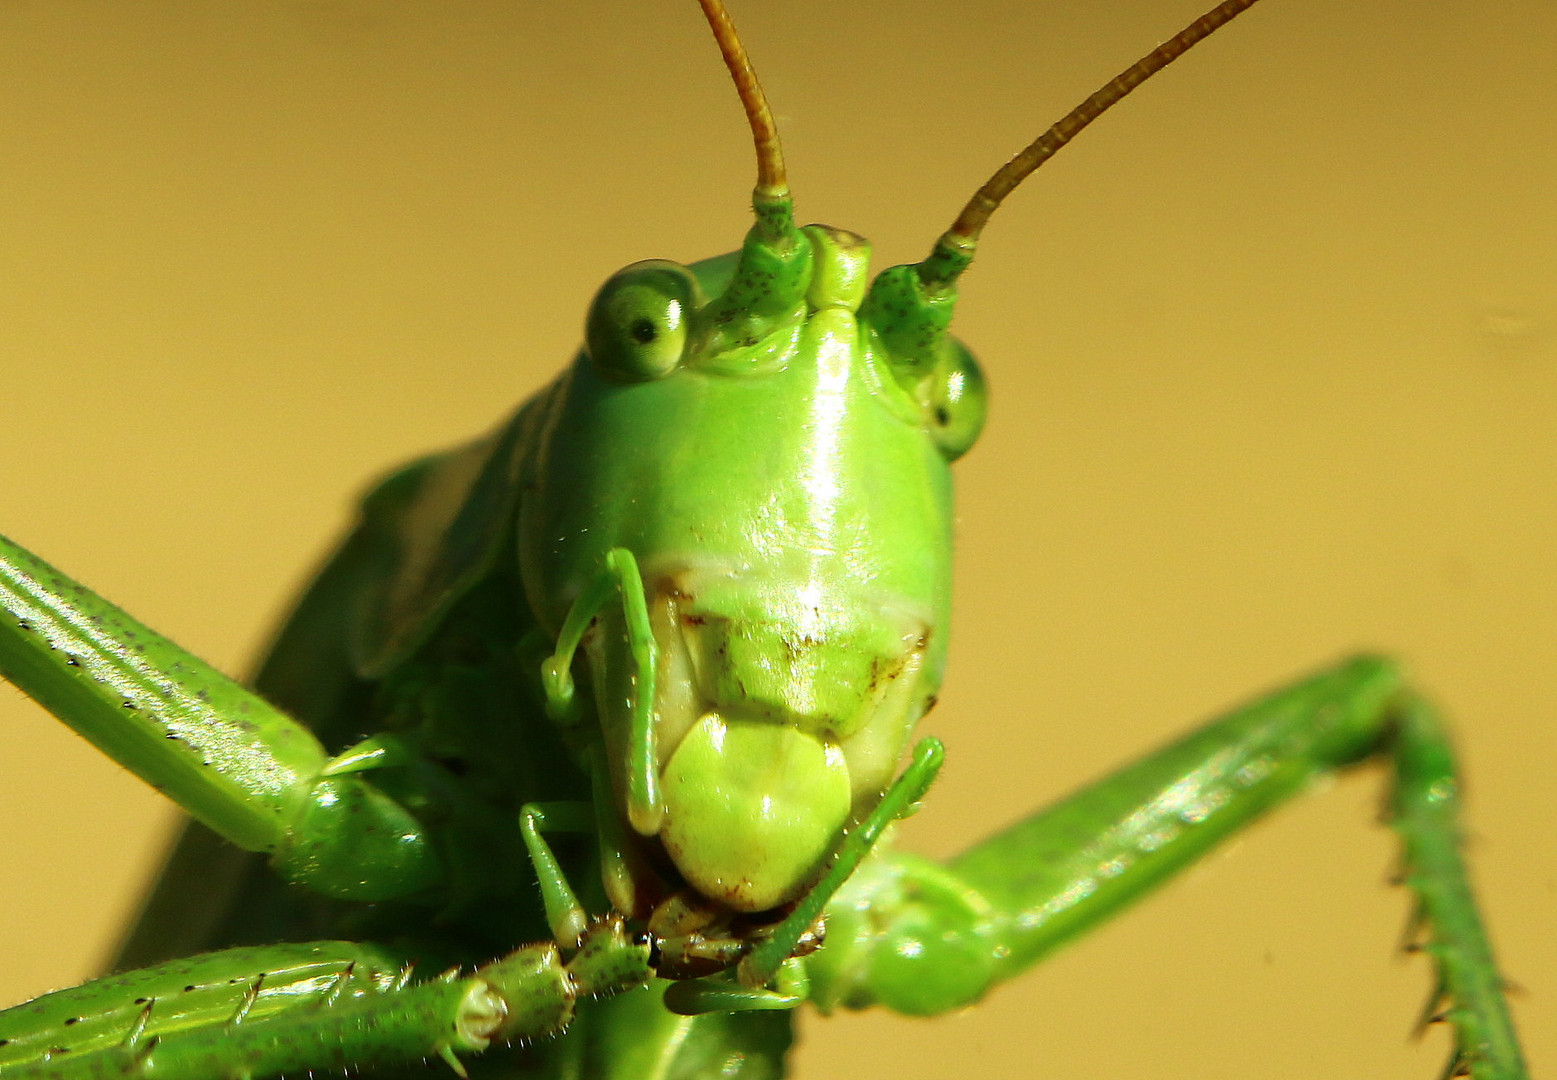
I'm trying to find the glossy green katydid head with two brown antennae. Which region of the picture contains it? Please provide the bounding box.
[518,0,1253,933]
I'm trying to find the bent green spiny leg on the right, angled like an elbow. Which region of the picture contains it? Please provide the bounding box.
[811,657,1527,1080]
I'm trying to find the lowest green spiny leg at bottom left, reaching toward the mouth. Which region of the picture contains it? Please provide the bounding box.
[0,918,651,1080]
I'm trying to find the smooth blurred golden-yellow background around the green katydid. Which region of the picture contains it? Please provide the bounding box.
[0,0,1557,1080]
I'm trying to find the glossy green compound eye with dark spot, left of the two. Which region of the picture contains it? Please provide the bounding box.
[584,258,698,383]
